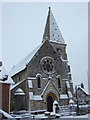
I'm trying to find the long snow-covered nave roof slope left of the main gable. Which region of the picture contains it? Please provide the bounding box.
[10,45,41,76]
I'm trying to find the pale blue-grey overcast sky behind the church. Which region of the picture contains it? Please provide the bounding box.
[2,2,88,90]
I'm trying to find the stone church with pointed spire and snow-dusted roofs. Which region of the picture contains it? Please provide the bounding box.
[11,7,73,112]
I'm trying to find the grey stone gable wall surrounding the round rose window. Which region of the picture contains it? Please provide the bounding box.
[27,41,67,79]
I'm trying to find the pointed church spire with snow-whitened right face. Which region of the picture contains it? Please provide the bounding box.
[42,7,65,43]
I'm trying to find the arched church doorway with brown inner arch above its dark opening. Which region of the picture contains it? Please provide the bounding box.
[47,92,57,112]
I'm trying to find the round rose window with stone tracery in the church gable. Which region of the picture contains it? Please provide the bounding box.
[40,56,55,74]
